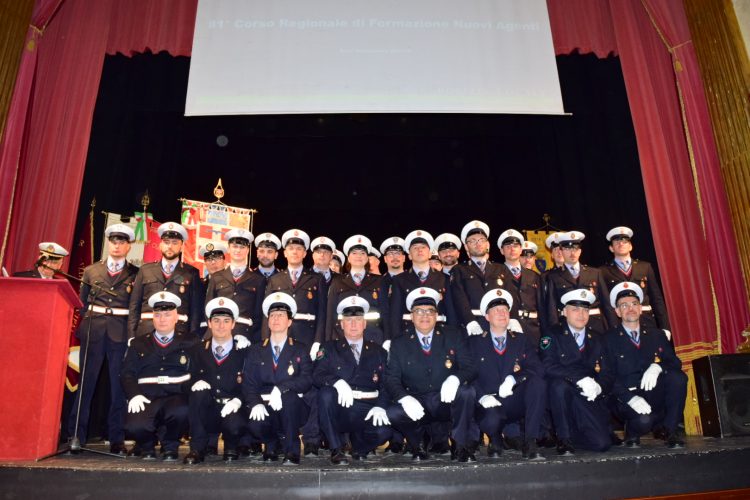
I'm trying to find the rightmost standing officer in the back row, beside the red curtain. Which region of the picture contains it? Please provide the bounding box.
[600,226,670,330]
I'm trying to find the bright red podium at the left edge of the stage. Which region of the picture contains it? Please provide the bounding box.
[0,278,82,460]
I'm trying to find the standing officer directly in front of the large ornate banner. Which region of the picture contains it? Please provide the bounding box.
[206,229,266,347]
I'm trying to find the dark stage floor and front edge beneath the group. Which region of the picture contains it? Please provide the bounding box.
[0,437,750,500]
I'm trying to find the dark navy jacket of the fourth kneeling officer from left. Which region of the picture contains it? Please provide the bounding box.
[313,338,389,408]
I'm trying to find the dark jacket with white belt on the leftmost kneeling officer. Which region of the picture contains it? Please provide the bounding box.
[120,331,197,399]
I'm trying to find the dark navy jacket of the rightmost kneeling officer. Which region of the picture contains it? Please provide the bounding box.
[604,325,682,404]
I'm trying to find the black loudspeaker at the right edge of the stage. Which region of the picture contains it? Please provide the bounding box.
[693,354,750,437]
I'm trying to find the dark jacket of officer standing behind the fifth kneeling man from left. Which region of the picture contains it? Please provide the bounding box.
[390,268,459,338]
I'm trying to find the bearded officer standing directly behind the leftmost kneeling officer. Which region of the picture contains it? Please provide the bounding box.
[128,222,204,337]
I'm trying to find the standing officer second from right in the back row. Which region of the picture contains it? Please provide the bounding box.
[547,231,617,333]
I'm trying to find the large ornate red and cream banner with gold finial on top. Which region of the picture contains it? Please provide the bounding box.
[180,200,251,276]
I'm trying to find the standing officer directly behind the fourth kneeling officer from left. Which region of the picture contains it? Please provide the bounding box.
[325,234,390,346]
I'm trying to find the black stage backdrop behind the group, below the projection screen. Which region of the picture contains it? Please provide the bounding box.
[79,53,656,272]
